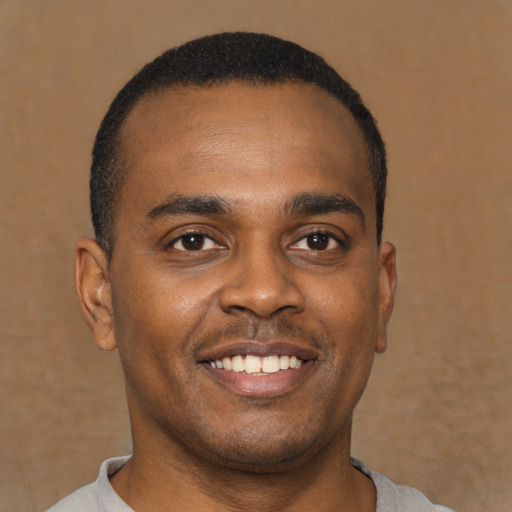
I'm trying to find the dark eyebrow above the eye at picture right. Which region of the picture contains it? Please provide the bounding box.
[287,194,365,225]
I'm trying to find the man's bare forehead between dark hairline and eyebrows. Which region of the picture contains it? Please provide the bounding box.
[118,82,373,220]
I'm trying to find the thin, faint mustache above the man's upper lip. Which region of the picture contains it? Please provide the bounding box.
[194,318,326,349]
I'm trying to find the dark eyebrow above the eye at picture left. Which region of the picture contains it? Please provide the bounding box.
[147,195,231,220]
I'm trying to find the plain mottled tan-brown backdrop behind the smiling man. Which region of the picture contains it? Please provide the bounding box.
[0,0,512,512]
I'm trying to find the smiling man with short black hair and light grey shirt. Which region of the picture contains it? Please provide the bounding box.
[50,33,454,512]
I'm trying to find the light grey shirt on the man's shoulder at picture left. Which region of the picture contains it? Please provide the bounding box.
[46,456,133,512]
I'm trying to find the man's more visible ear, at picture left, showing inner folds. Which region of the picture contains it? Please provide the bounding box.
[75,238,116,350]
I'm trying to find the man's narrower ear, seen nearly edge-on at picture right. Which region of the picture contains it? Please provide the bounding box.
[375,242,396,354]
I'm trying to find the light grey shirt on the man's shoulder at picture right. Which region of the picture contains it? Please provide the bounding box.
[352,459,453,512]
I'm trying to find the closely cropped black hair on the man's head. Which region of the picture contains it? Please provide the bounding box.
[90,32,387,260]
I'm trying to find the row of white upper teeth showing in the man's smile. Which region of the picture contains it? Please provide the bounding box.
[209,354,303,375]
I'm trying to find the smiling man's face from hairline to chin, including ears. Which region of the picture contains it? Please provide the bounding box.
[79,83,395,470]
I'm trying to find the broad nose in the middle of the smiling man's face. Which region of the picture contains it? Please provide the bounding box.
[220,243,304,318]
